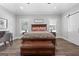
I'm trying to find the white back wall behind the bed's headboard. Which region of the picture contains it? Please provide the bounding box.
[17,15,61,36]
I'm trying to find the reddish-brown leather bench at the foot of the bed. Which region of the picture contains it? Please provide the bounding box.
[21,41,55,56]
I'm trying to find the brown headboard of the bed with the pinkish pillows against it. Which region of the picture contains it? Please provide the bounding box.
[31,24,47,31]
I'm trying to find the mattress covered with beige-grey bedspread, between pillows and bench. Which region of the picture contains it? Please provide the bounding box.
[22,31,55,39]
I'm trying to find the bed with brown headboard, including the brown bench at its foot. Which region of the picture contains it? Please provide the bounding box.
[21,24,55,56]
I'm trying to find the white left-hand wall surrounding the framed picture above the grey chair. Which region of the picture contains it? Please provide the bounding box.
[0,6,16,38]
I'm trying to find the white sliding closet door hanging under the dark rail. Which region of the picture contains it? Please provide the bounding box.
[68,13,79,45]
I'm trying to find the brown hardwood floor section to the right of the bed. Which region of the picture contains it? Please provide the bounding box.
[56,38,79,56]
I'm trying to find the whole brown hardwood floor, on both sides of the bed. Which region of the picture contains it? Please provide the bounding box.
[0,38,79,56]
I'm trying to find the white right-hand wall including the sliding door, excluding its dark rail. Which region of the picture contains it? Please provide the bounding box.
[62,4,79,45]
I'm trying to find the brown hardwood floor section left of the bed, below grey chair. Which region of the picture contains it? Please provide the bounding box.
[0,40,21,56]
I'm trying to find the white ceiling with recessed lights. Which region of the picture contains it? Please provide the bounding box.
[0,3,77,15]
